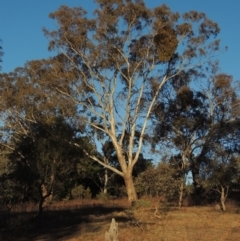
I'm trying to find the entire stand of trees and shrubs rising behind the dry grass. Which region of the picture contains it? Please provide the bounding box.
[0,0,240,211]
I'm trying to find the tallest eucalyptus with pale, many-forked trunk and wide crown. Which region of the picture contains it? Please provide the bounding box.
[41,0,219,201]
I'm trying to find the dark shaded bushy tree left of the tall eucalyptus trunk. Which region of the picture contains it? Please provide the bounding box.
[5,117,96,206]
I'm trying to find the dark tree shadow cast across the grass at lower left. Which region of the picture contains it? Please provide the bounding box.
[0,205,127,241]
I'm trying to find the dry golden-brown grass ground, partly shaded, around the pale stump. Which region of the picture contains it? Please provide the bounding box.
[1,200,240,241]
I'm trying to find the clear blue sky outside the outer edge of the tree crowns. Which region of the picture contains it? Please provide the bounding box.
[0,0,240,80]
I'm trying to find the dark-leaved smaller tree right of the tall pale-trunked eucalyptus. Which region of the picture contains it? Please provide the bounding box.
[154,70,240,202]
